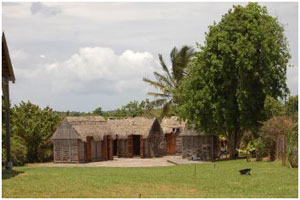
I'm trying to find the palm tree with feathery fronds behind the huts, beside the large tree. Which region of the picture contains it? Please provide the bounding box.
[143,46,194,118]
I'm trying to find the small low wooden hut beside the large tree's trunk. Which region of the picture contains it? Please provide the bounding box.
[181,129,219,161]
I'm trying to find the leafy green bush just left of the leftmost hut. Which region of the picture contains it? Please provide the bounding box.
[11,101,61,162]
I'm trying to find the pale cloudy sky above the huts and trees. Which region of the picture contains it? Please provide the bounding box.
[2,2,298,112]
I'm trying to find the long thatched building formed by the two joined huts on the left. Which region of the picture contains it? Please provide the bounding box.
[51,116,166,162]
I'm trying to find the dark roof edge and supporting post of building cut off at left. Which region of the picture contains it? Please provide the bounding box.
[2,33,15,170]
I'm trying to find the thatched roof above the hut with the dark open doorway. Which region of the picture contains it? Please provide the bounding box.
[107,117,159,139]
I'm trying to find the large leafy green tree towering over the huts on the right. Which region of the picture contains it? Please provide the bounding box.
[178,3,290,157]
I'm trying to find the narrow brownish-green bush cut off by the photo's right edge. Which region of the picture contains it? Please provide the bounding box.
[287,122,298,167]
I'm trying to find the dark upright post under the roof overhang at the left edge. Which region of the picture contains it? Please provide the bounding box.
[2,77,12,170]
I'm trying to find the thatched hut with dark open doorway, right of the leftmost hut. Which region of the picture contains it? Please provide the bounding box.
[108,117,166,158]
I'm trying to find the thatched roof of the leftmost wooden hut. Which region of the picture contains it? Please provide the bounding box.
[51,116,112,142]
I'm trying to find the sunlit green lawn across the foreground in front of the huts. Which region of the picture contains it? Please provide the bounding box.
[2,160,298,198]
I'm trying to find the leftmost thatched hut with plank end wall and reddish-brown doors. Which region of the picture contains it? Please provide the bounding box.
[51,116,113,162]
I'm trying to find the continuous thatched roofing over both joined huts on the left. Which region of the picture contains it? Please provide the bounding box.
[51,116,160,142]
